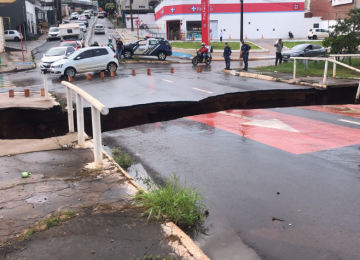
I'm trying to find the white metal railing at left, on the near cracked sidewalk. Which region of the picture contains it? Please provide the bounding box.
[61,81,109,166]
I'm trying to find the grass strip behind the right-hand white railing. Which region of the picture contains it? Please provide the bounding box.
[256,58,360,78]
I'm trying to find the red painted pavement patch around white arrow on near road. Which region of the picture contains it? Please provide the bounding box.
[187,110,360,154]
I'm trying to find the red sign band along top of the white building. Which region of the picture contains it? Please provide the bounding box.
[155,2,305,20]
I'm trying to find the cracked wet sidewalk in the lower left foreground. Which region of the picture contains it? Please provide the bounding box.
[0,133,208,260]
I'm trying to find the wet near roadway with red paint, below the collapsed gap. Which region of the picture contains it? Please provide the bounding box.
[103,108,360,260]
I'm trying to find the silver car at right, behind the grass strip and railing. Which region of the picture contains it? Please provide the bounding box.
[283,44,328,61]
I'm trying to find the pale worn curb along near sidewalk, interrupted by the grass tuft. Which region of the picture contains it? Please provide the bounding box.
[102,150,210,260]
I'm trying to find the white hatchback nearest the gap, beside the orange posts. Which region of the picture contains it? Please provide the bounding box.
[50,47,119,77]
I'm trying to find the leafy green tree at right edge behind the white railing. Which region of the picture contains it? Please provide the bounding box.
[323,9,360,65]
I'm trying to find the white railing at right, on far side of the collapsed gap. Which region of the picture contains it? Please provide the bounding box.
[291,54,360,102]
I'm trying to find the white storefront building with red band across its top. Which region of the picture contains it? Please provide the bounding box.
[155,0,321,40]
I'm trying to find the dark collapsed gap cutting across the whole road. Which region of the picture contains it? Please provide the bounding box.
[0,85,358,139]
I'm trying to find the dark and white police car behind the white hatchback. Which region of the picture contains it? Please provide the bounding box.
[123,37,172,60]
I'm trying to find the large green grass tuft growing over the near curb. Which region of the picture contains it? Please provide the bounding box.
[133,174,207,227]
